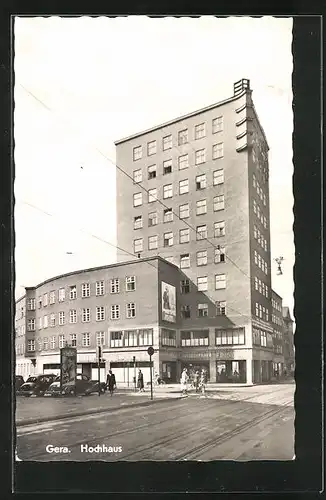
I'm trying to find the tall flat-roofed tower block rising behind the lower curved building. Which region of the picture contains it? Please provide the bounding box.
[115,79,273,383]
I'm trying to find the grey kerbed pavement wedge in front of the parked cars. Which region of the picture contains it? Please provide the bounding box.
[16,392,180,426]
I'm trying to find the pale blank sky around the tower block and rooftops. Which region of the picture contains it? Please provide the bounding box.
[14,16,294,318]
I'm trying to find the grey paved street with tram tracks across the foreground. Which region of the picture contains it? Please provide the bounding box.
[17,384,295,461]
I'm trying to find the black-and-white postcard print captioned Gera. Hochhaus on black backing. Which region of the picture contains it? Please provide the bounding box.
[13,15,296,462]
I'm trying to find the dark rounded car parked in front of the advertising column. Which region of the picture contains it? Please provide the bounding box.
[44,373,106,396]
